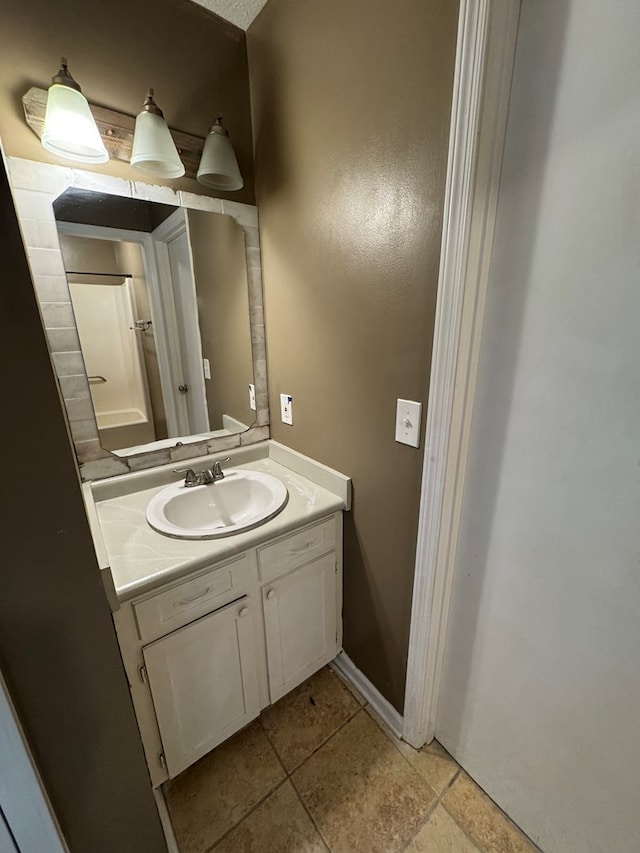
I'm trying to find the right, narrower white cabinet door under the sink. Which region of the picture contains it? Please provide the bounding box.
[262,552,338,702]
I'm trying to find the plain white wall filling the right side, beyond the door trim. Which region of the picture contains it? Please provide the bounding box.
[437,0,640,853]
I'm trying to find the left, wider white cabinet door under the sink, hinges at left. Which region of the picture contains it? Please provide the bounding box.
[142,599,260,778]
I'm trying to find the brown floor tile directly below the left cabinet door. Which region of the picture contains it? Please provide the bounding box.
[165,722,285,853]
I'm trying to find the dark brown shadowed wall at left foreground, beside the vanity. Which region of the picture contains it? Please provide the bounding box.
[0,156,166,853]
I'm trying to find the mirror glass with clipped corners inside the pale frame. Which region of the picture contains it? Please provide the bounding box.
[53,188,255,456]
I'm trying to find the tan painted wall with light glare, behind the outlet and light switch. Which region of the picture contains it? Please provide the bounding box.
[248,0,458,710]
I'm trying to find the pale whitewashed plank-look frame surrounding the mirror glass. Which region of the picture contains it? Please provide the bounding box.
[6,157,270,480]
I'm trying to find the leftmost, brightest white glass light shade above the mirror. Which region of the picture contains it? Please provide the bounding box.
[41,83,109,163]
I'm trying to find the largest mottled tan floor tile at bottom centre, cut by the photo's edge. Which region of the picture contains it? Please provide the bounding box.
[291,711,435,853]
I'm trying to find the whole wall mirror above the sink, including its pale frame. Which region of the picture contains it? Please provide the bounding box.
[9,158,268,479]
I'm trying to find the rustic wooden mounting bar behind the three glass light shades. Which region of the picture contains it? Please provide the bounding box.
[22,86,204,179]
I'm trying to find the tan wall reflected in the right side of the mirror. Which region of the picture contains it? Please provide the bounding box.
[187,210,255,429]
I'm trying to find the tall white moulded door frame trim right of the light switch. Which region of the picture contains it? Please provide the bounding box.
[403,0,520,748]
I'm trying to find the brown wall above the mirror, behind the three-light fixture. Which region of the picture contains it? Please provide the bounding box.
[0,0,254,203]
